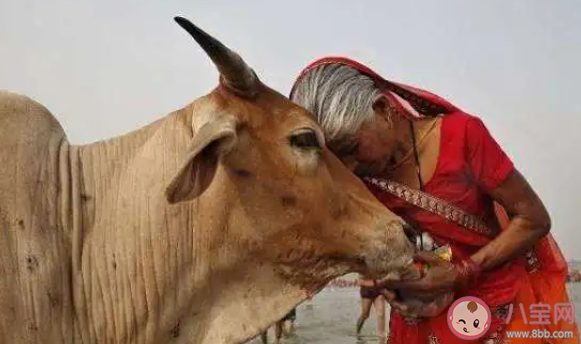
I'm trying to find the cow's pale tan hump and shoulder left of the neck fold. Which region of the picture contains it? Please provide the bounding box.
[0,92,74,343]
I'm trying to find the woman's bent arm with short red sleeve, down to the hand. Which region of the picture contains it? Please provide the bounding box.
[376,117,551,294]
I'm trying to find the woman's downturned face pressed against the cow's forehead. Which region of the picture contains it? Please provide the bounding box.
[331,112,397,177]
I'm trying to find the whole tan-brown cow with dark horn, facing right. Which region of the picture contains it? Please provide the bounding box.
[0,17,413,344]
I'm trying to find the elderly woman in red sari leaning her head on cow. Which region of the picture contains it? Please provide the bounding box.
[290,57,578,344]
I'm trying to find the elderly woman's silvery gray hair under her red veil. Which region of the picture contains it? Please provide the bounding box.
[291,64,381,143]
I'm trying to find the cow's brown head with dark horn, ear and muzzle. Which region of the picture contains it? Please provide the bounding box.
[166,17,413,289]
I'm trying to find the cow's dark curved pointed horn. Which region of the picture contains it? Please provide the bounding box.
[174,17,258,97]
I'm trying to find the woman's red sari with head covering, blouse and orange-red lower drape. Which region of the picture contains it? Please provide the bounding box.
[291,57,579,344]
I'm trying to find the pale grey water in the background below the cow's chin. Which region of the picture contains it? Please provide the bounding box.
[249,283,581,344]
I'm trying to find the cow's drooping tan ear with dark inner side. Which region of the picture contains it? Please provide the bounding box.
[165,118,237,204]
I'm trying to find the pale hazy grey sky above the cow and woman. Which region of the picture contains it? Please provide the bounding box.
[0,0,581,258]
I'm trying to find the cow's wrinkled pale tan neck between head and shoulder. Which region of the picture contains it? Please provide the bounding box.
[71,101,306,344]
